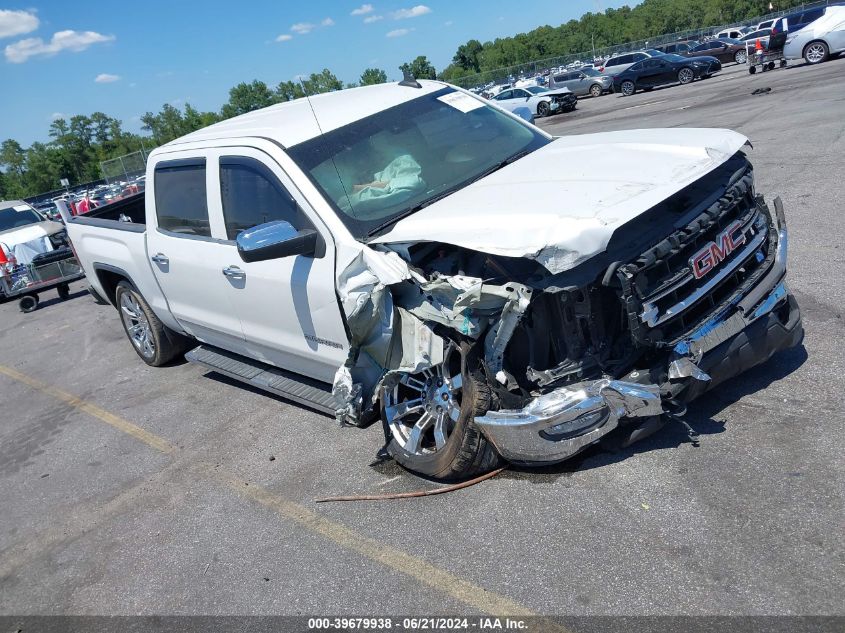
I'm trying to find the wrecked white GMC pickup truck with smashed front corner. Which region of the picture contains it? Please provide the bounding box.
[65,80,803,479]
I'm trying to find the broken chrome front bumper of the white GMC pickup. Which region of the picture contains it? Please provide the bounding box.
[475,199,800,463]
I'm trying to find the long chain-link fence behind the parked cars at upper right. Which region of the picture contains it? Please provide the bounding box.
[454,0,841,88]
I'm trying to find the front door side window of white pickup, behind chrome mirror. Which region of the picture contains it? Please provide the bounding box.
[220,156,305,240]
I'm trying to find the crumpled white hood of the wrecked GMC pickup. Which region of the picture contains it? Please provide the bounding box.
[372,128,748,273]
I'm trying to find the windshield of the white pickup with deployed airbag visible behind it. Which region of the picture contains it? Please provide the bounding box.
[288,88,551,239]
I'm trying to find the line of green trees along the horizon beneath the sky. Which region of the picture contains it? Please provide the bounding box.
[0,0,812,199]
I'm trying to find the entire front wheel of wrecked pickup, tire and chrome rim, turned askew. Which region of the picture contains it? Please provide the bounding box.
[381,344,501,480]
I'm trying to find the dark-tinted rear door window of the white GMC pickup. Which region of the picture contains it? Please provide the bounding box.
[155,158,211,237]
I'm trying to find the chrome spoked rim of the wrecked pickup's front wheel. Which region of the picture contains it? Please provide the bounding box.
[384,343,463,455]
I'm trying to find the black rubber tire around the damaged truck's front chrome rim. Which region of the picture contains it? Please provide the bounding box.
[382,350,502,481]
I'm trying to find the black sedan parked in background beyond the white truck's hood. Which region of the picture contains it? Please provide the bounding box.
[613,55,722,96]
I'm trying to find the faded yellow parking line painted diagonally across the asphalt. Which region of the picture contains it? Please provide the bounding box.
[0,365,565,631]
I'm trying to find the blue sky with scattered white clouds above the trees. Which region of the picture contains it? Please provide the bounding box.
[0,0,636,146]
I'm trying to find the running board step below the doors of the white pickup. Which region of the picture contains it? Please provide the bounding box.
[185,345,336,416]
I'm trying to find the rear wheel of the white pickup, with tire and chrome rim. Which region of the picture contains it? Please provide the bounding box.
[115,281,187,367]
